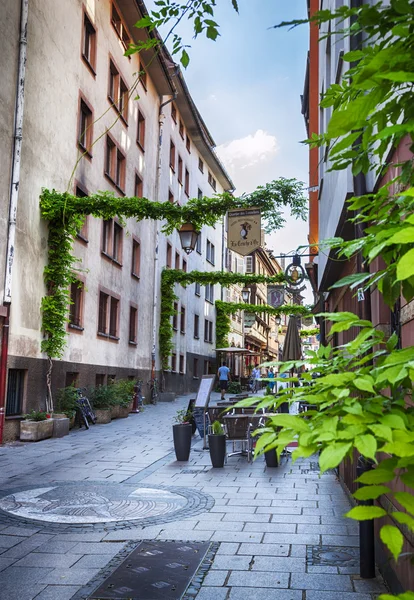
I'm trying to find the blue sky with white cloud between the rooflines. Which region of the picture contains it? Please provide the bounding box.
[147,0,309,300]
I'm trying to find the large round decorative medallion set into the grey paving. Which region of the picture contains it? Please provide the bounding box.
[0,482,212,526]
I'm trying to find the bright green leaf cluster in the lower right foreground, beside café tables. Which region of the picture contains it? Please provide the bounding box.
[239,312,414,560]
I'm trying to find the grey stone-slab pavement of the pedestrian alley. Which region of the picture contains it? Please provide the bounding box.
[0,396,385,600]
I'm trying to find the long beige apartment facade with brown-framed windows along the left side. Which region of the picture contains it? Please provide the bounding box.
[0,0,233,434]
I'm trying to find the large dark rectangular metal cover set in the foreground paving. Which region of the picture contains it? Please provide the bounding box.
[88,542,210,600]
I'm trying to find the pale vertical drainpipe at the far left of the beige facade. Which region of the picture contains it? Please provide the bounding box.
[0,0,29,444]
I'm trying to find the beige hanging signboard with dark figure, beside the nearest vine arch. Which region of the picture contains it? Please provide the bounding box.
[227,208,261,256]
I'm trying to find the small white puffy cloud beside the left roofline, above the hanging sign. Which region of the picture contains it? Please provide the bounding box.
[216,129,279,175]
